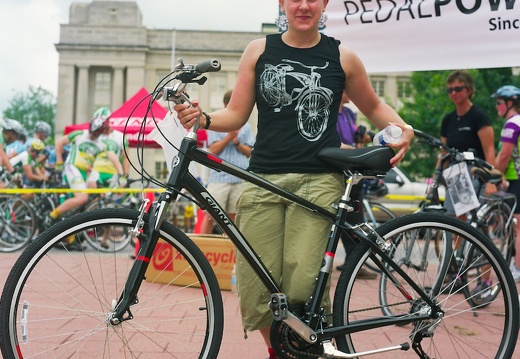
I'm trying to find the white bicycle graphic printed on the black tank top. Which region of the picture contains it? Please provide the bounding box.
[260,60,333,141]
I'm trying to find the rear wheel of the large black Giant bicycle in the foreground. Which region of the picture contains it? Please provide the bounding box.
[333,213,520,359]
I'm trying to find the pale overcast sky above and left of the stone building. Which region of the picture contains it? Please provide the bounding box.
[0,0,278,115]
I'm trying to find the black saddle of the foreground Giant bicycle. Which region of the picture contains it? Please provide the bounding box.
[318,146,395,176]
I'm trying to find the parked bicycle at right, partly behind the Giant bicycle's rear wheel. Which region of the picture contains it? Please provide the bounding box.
[380,130,517,314]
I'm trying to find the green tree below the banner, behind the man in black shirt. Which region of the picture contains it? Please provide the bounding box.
[399,68,520,178]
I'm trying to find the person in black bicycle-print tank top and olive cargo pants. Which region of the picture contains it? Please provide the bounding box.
[174,0,413,358]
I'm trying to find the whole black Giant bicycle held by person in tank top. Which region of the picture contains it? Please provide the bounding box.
[0,60,520,359]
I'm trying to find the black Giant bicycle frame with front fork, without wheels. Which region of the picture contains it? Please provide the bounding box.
[111,132,438,343]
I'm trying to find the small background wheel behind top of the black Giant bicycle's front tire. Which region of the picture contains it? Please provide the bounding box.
[79,198,132,253]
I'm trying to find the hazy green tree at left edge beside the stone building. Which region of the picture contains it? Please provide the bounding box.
[3,86,56,141]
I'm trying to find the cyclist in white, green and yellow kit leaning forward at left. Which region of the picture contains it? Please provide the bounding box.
[45,111,123,250]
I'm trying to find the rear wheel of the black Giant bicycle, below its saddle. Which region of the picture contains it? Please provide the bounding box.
[333,213,520,359]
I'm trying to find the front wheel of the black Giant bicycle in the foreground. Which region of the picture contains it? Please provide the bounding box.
[0,209,223,359]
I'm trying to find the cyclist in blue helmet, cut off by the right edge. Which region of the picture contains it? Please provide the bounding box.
[491,85,520,282]
